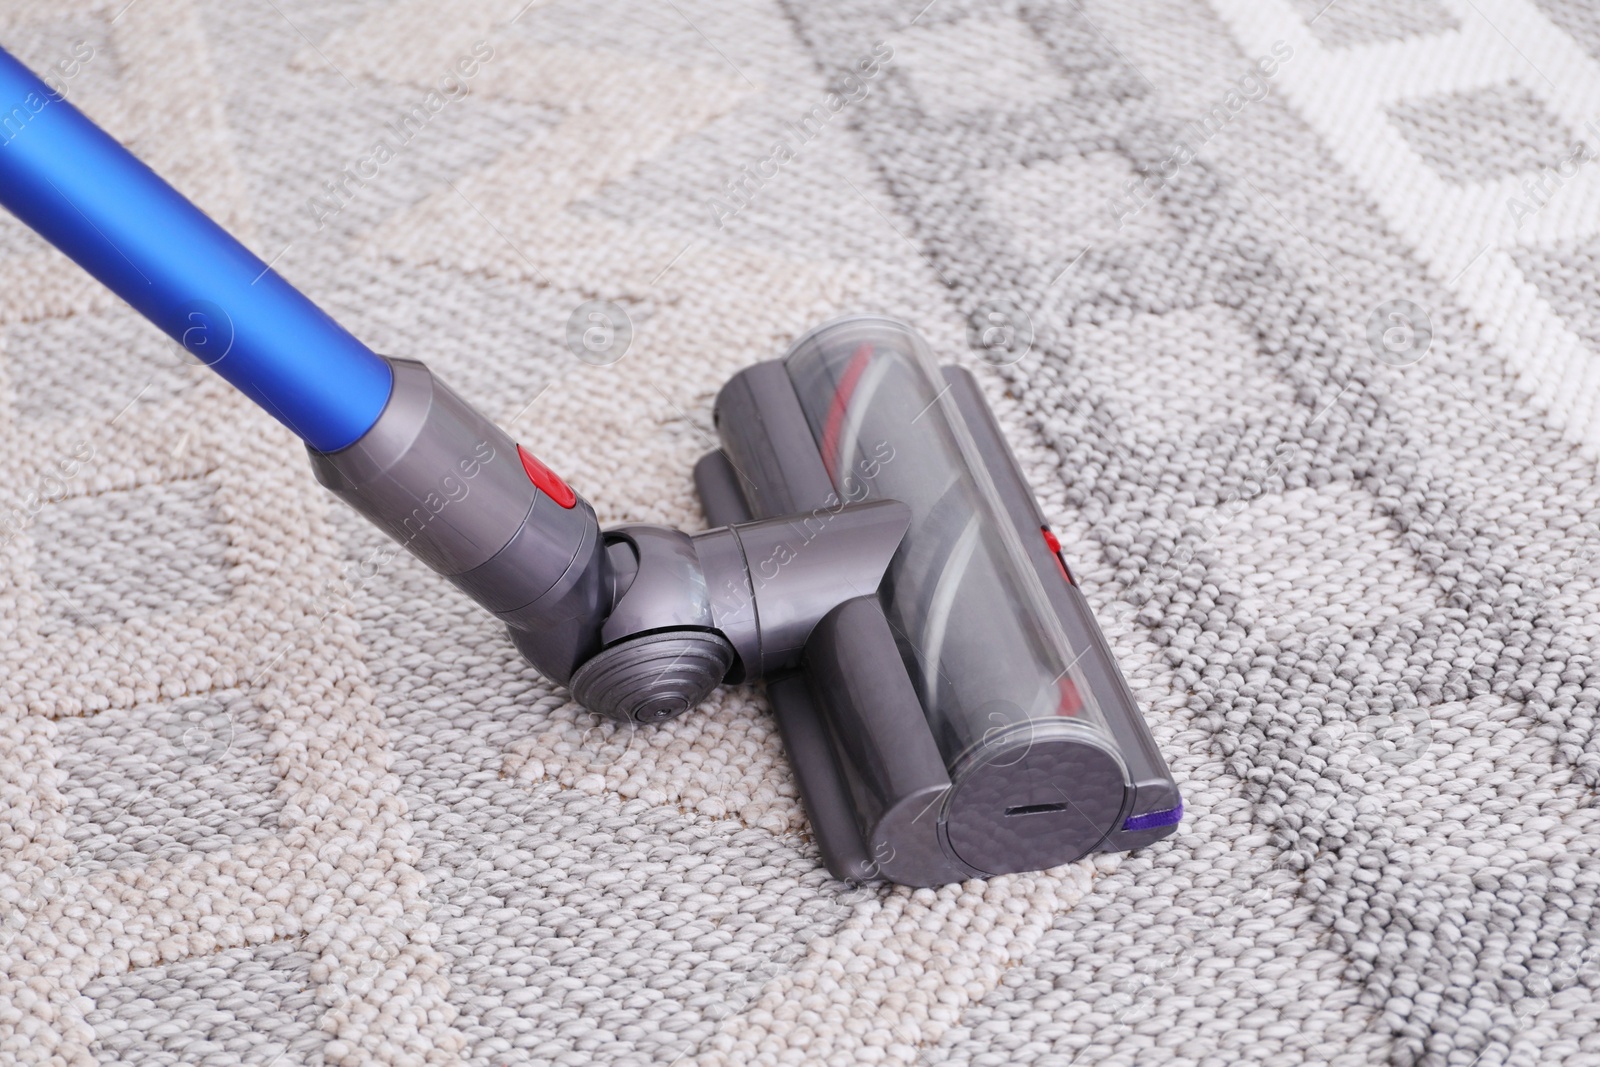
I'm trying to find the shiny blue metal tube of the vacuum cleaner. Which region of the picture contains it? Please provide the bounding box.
[0,50,392,451]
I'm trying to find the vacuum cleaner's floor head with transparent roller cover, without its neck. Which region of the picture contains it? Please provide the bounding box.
[696,317,1182,885]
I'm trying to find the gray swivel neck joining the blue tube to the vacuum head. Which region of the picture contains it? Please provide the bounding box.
[310,360,909,721]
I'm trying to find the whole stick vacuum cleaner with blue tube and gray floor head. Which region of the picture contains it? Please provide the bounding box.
[0,51,1182,886]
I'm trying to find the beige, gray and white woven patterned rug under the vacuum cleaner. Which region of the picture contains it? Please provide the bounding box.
[0,0,1600,1067]
